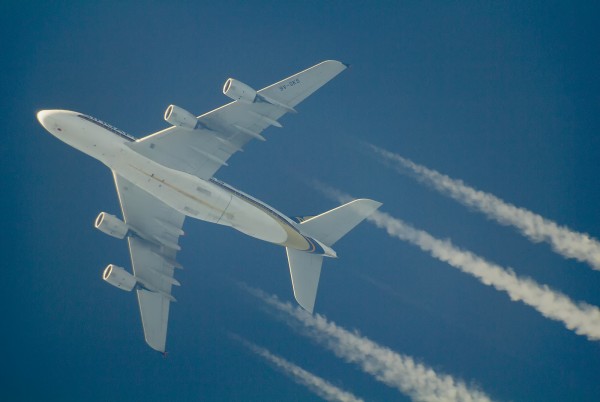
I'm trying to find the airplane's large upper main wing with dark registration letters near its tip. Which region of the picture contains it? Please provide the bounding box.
[129,60,347,179]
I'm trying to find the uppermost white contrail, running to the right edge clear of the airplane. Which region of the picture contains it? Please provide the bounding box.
[369,145,600,270]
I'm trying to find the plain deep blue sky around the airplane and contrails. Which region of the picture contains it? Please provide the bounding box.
[0,1,600,401]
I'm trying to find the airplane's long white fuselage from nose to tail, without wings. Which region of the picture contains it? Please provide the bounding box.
[38,110,335,257]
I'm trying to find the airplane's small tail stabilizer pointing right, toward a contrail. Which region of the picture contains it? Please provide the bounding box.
[300,199,381,246]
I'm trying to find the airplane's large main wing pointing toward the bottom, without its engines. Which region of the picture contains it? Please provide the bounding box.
[114,174,185,352]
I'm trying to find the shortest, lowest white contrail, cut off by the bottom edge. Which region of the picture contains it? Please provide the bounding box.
[231,334,363,402]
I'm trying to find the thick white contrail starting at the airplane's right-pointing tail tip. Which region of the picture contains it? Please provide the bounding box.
[367,212,600,341]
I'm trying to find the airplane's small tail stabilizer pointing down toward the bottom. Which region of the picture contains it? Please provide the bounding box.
[285,248,323,313]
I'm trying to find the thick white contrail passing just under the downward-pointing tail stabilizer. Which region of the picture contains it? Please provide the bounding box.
[246,287,491,402]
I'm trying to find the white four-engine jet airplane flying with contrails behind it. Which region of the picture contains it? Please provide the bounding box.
[37,60,381,353]
